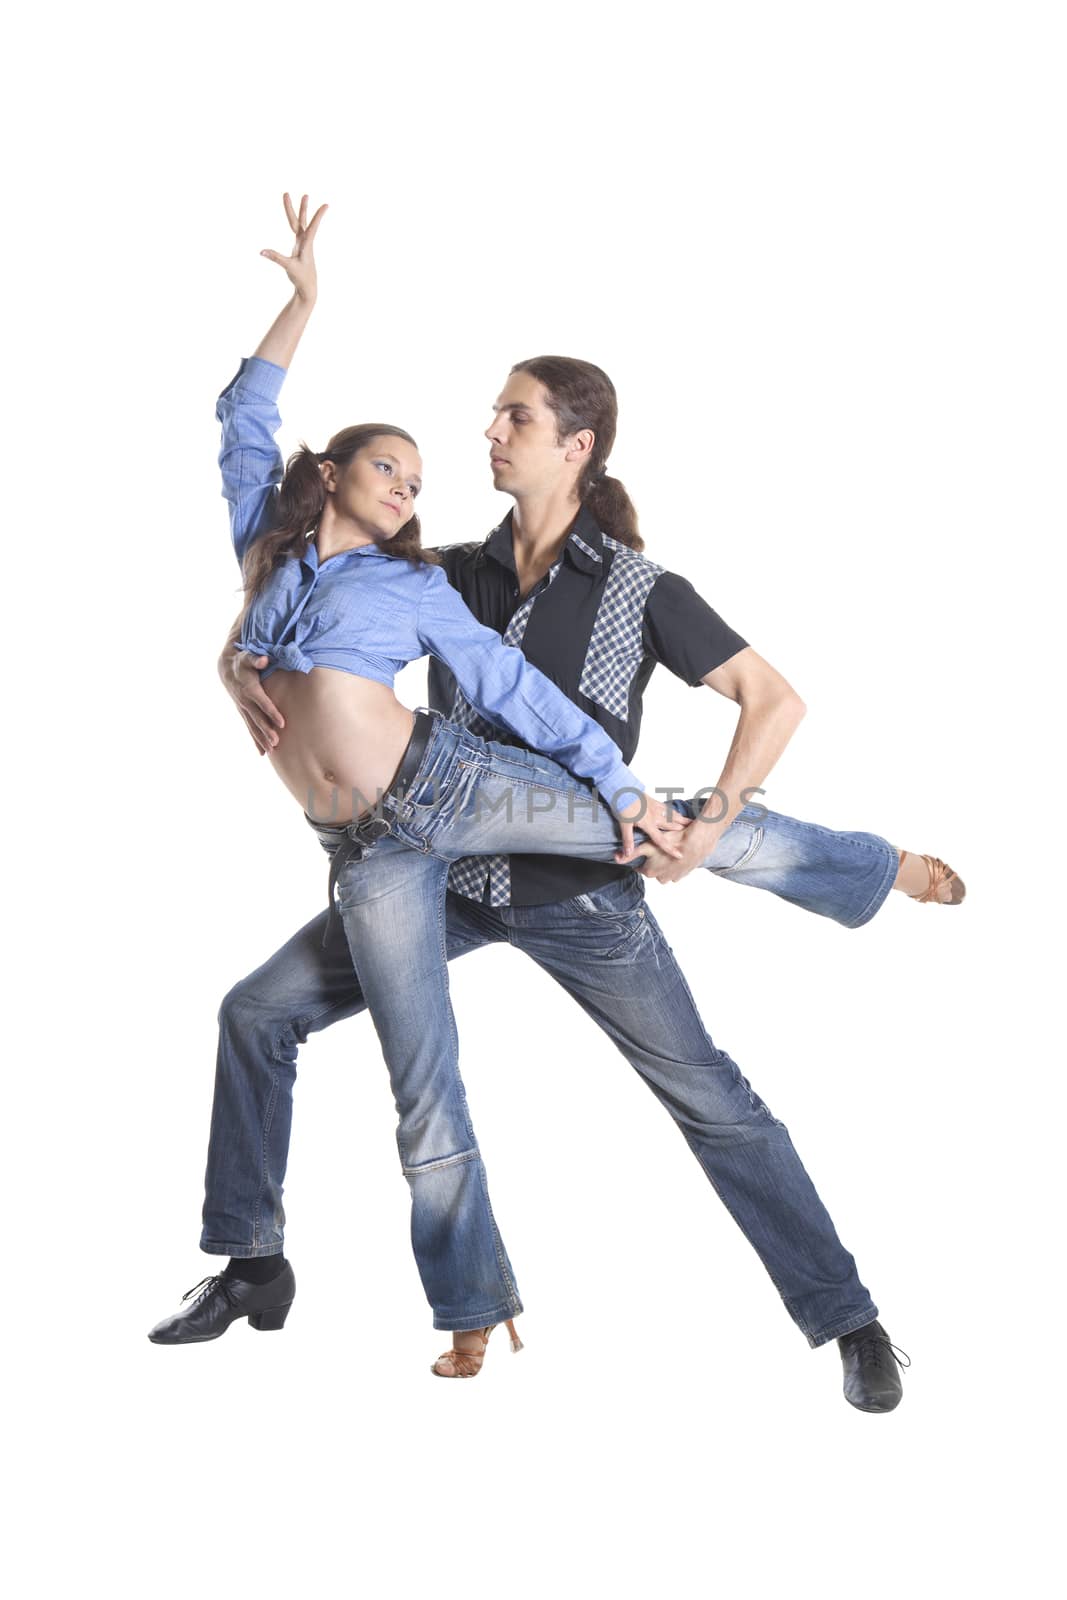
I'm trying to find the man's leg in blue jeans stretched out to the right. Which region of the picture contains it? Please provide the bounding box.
[499,874,878,1347]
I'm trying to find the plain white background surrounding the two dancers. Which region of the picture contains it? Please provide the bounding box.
[5,0,1067,1597]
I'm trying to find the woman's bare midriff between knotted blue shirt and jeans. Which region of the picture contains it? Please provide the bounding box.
[264,667,414,822]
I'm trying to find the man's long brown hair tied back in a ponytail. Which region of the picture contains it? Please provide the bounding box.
[512,355,645,550]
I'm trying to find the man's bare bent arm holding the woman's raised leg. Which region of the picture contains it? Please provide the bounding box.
[638,646,806,883]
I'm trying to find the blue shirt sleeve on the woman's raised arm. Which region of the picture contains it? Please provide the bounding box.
[214,355,285,562]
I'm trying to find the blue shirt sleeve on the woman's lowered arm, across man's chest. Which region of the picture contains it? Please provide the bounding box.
[418,566,645,806]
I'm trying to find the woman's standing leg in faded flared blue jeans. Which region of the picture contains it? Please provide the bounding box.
[329,835,522,1331]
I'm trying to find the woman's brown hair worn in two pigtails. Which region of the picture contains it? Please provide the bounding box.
[245,422,437,608]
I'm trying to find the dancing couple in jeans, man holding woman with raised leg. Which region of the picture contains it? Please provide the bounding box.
[149,195,963,1411]
